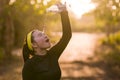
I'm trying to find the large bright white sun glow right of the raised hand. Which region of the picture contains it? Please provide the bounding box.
[61,0,95,18]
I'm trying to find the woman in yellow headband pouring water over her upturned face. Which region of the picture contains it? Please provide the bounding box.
[22,5,72,80]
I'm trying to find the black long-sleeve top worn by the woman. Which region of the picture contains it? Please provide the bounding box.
[22,11,72,80]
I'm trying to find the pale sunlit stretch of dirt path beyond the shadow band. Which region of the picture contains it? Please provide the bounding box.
[60,33,100,62]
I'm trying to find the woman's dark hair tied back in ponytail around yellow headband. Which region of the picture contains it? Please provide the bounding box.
[22,31,35,62]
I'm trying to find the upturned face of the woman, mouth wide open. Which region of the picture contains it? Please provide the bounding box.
[32,30,51,49]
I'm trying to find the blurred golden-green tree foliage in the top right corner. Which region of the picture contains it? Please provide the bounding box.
[92,0,120,35]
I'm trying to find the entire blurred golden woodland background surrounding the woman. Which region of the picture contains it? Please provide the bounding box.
[0,0,120,80]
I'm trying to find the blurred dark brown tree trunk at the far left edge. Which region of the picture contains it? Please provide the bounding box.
[0,0,14,56]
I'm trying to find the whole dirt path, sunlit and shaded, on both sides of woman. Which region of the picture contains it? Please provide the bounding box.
[0,33,119,80]
